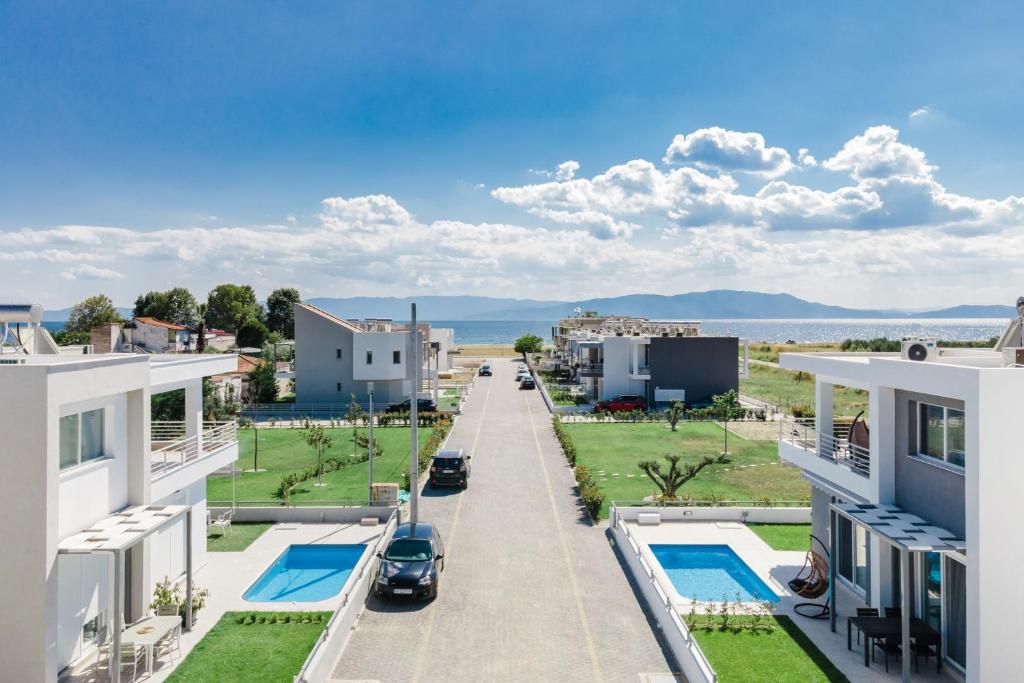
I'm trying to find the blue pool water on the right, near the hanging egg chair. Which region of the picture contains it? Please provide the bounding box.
[650,544,778,602]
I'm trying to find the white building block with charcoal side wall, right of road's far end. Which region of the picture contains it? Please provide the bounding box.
[555,316,740,405]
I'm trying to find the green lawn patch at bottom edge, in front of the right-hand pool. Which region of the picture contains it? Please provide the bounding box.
[693,616,849,683]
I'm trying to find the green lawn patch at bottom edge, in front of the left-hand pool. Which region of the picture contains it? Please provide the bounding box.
[167,612,331,683]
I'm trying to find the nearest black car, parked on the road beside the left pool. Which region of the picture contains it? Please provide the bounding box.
[374,522,444,599]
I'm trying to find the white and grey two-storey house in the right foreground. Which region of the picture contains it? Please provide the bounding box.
[779,325,1024,681]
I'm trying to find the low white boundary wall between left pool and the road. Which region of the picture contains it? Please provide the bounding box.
[293,511,399,683]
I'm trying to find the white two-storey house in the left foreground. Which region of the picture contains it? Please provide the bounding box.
[0,310,238,681]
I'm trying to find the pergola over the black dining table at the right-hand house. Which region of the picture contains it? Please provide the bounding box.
[828,503,967,681]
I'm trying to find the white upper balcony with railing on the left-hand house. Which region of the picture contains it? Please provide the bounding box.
[150,421,239,500]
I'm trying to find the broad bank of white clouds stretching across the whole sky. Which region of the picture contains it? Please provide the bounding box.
[8,127,1024,306]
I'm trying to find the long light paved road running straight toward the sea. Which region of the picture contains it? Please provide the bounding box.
[334,358,674,683]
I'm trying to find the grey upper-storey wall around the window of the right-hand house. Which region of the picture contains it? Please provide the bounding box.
[894,390,962,536]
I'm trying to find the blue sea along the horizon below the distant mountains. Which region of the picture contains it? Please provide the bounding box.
[43,317,1009,345]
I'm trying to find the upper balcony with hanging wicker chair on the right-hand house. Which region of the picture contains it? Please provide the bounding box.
[778,419,871,497]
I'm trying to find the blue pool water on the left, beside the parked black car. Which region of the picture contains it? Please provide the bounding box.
[243,544,366,602]
